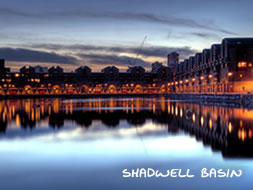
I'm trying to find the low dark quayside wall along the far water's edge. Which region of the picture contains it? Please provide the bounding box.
[0,93,253,109]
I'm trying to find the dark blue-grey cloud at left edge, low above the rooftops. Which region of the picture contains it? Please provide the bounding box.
[0,48,78,65]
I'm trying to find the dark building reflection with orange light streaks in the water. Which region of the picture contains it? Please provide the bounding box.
[0,98,253,157]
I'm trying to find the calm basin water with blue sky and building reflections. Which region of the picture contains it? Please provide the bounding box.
[0,98,253,190]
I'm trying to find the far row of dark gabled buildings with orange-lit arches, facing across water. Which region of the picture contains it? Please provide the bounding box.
[0,62,171,96]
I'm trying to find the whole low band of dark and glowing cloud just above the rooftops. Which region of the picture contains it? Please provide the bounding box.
[0,44,197,70]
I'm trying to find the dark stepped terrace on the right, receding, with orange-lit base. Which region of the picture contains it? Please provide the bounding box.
[168,38,253,93]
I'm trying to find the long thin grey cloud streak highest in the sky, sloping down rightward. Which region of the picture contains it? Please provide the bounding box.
[0,8,235,35]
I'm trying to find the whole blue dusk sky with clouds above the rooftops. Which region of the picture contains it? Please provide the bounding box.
[0,0,253,71]
